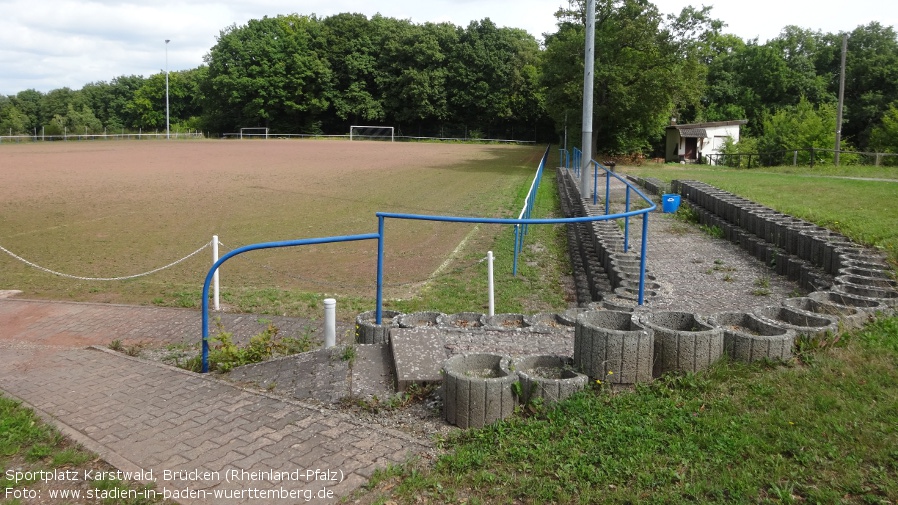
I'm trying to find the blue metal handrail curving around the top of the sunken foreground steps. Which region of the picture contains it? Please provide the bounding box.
[202,149,656,373]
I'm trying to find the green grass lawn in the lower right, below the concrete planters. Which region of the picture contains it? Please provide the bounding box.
[356,318,898,504]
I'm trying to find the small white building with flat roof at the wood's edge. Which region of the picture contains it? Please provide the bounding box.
[664,119,748,163]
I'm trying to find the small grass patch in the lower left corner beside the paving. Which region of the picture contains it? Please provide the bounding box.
[0,395,170,505]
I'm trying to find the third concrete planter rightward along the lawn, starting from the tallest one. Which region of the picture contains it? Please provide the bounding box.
[709,312,795,362]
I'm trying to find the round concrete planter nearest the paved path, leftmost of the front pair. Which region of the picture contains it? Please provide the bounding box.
[443,354,518,428]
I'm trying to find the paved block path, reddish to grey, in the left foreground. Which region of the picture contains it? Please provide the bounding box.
[0,299,427,504]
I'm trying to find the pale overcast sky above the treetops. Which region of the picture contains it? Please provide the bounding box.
[0,0,898,95]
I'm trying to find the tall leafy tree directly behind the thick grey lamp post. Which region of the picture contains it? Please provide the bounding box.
[543,0,721,154]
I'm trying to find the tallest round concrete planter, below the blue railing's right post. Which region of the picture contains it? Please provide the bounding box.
[574,310,654,384]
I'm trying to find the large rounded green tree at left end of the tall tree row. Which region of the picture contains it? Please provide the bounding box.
[203,14,332,132]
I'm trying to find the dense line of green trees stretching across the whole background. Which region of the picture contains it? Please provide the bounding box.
[0,0,898,154]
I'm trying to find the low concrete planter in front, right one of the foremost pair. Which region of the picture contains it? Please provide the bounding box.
[512,355,589,404]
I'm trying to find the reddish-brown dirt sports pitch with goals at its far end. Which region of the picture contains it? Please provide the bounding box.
[0,140,542,312]
